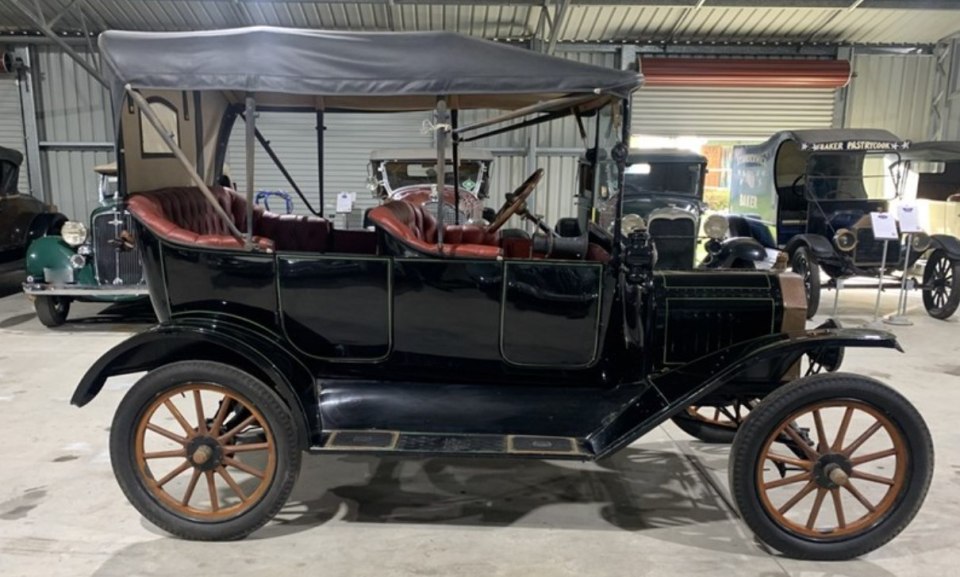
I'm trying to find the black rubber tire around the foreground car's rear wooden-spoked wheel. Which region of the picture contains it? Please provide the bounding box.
[110,361,301,541]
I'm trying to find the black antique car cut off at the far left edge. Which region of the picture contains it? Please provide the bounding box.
[0,146,67,270]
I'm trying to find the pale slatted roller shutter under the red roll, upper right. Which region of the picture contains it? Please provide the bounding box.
[631,87,836,140]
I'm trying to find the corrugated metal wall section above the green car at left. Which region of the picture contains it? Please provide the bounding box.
[32,46,114,221]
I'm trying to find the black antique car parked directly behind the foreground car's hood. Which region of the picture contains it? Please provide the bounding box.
[600,149,769,270]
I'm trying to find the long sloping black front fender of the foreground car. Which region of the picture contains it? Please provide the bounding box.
[587,328,903,458]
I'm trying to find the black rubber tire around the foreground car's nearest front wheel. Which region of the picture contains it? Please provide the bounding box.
[730,373,933,561]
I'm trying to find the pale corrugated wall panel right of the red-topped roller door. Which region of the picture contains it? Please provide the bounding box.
[845,53,936,140]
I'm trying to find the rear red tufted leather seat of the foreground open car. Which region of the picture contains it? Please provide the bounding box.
[127,186,331,252]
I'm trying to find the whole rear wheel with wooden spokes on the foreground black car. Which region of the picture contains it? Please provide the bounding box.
[110,361,300,541]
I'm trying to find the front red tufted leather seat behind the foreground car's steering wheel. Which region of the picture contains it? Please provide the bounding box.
[368,200,502,258]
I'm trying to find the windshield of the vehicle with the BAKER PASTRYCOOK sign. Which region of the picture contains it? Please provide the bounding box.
[806,153,898,200]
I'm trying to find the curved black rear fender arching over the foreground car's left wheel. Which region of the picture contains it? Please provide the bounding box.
[76,321,320,448]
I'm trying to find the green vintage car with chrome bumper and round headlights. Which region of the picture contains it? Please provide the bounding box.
[23,164,147,327]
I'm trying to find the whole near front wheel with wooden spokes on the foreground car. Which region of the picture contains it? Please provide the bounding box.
[730,373,933,560]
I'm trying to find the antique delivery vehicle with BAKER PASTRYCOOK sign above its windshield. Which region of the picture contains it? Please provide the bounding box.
[730,129,960,319]
